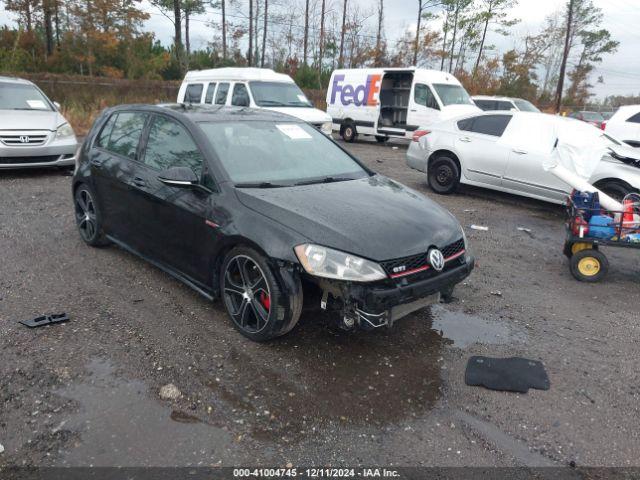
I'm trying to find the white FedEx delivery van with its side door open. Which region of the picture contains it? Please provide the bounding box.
[327,68,481,142]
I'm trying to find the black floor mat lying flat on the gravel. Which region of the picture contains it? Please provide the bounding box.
[464,356,550,393]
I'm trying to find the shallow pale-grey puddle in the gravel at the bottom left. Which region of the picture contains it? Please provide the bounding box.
[56,360,238,466]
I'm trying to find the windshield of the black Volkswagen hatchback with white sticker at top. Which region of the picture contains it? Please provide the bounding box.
[199,121,369,188]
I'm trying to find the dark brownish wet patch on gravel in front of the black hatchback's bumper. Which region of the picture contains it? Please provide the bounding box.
[203,314,449,441]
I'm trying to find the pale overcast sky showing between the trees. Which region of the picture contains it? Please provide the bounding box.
[0,0,640,98]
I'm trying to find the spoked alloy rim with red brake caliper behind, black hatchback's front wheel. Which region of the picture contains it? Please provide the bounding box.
[223,255,271,333]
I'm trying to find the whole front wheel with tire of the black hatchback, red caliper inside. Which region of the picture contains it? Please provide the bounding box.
[220,247,303,342]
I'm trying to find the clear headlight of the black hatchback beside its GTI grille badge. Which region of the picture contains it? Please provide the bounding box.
[294,243,387,282]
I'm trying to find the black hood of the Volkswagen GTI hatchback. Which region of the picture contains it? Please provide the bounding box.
[236,175,462,261]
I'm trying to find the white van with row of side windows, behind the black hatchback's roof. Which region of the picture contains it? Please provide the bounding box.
[178,68,331,135]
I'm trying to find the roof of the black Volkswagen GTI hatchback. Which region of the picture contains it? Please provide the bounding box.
[107,103,304,123]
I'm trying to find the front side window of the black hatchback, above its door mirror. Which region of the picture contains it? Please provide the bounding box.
[144,115,203,177]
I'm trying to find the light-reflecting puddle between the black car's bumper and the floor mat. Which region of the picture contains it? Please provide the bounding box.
[431,305,527,348]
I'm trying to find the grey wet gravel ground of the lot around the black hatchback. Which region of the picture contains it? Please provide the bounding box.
[0,136,640,466]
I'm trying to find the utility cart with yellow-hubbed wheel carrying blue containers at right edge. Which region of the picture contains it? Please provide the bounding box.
[564,192,640,282]
